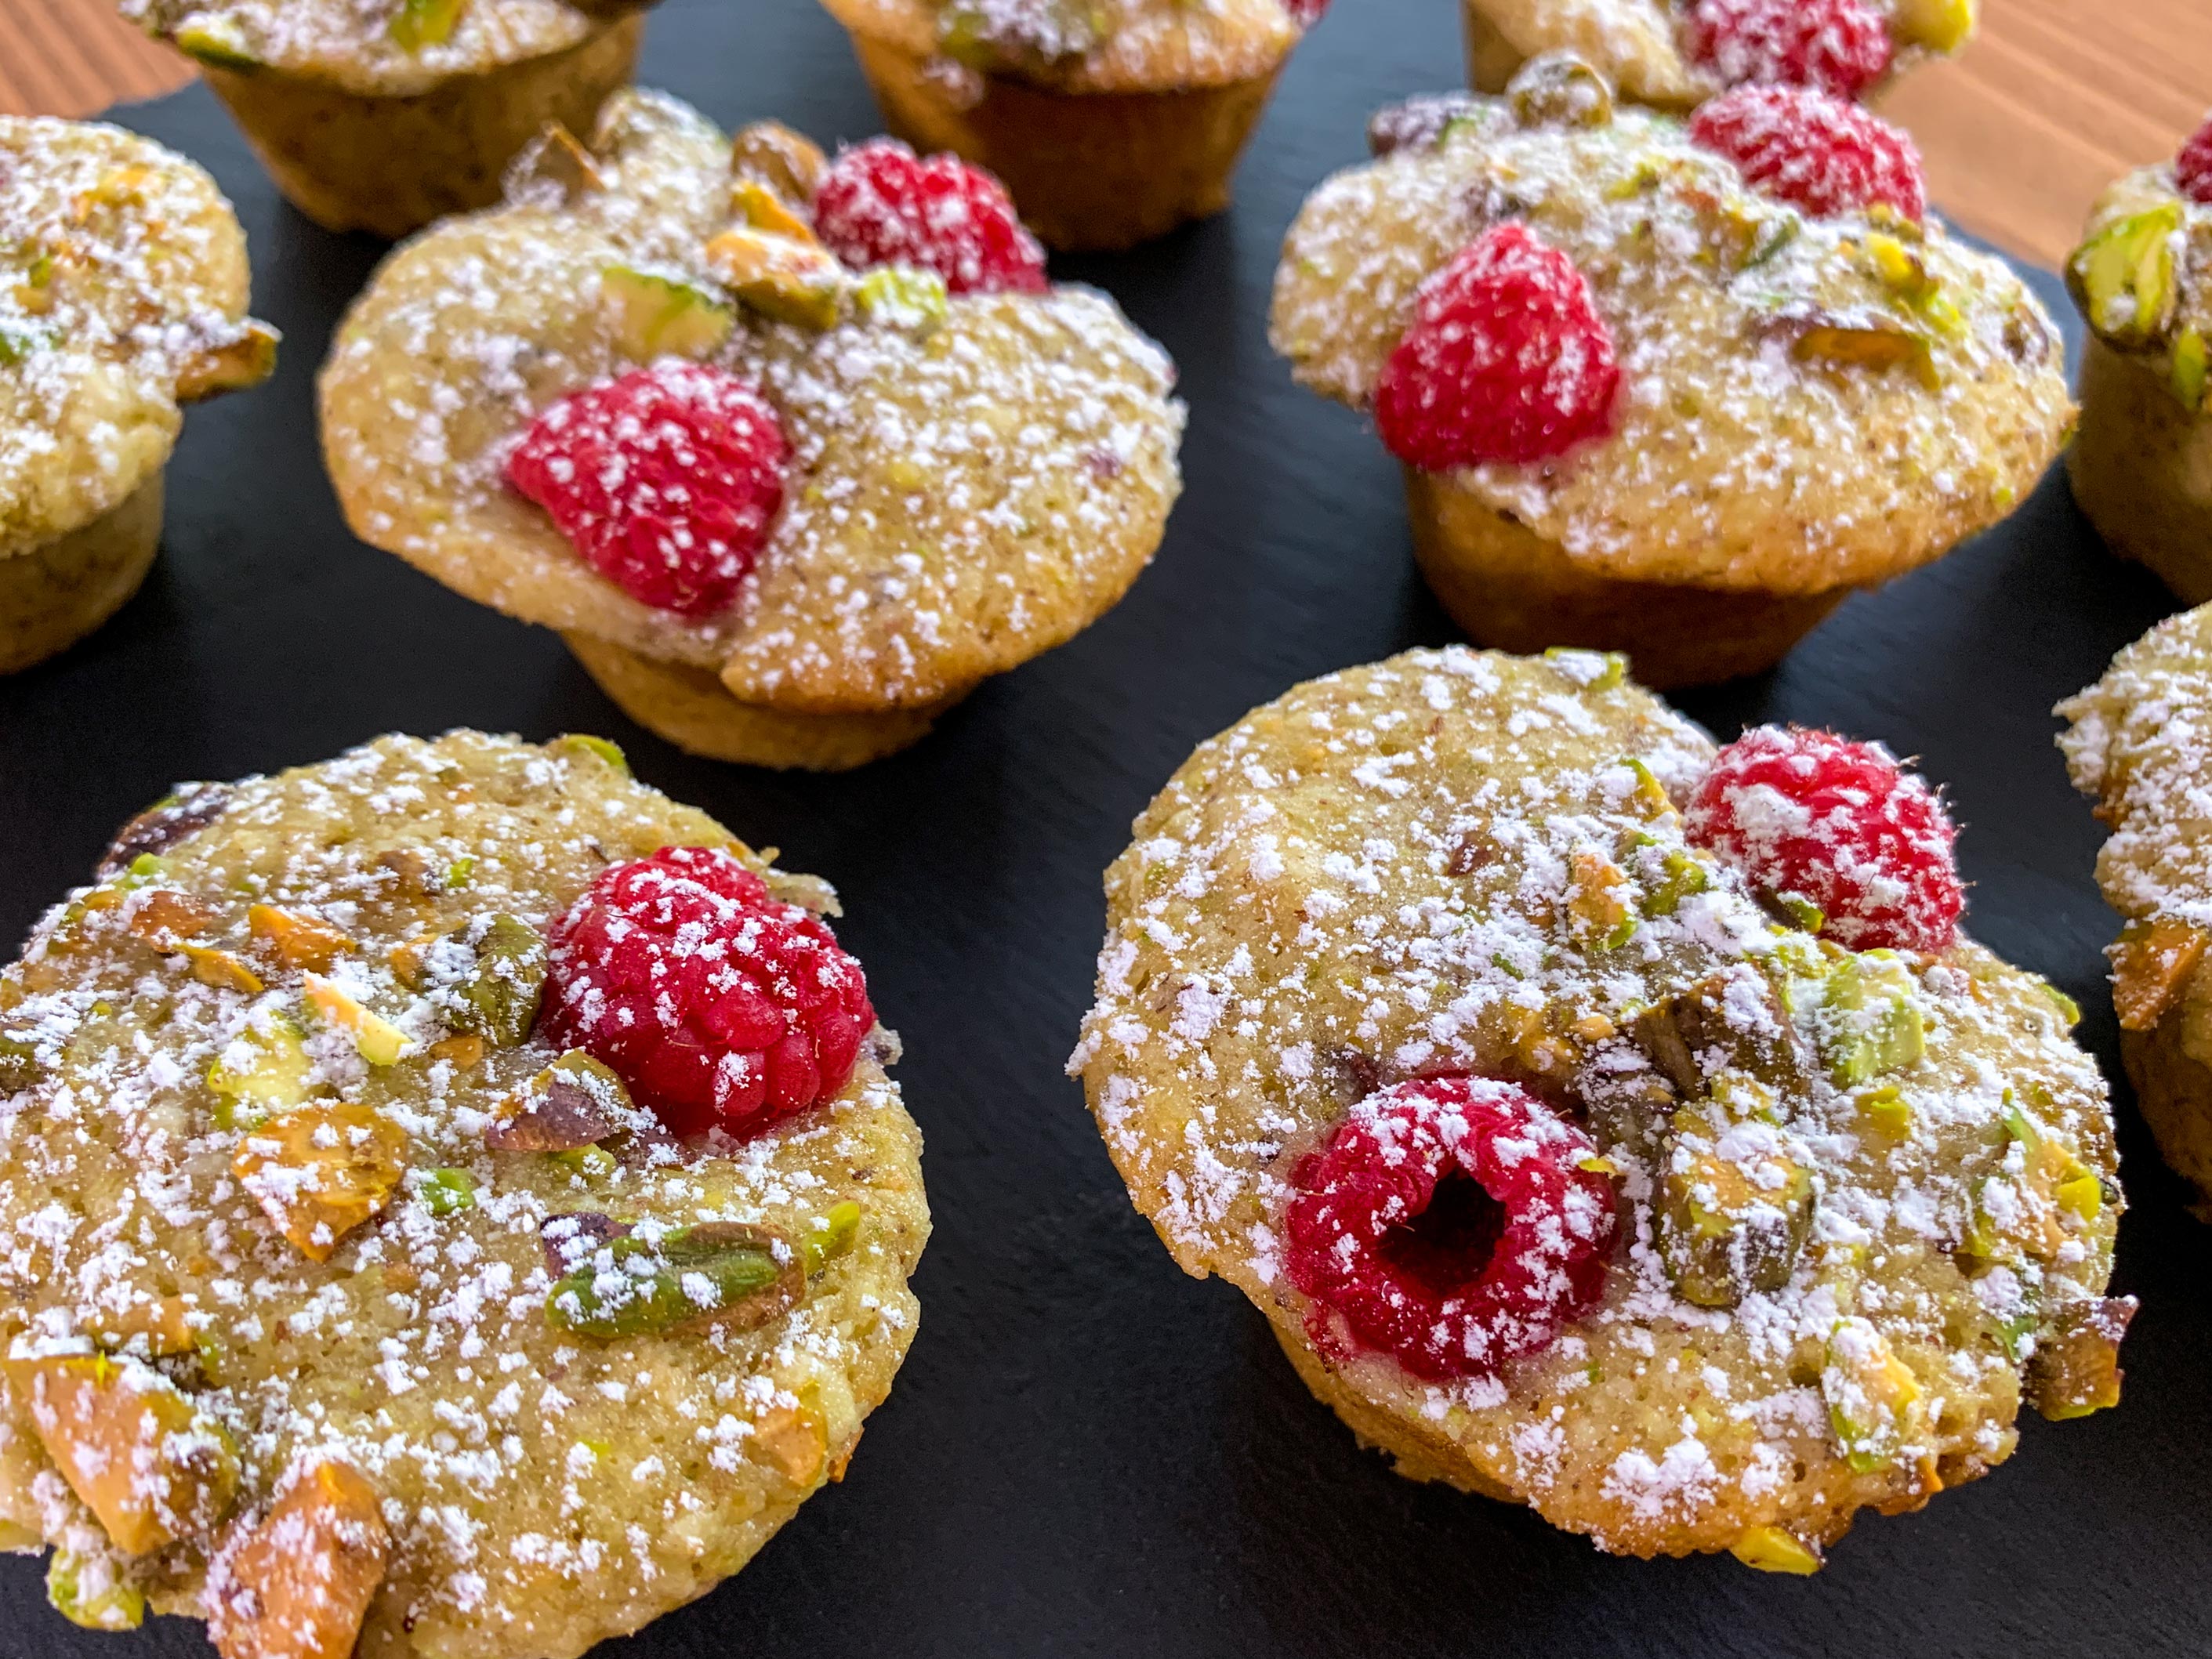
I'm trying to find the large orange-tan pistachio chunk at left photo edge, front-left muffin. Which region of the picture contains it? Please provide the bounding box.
[6,1353,239,1555]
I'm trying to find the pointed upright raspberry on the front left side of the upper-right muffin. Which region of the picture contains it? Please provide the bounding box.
[1376,223,1622,471]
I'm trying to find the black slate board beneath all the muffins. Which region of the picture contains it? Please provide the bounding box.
[0,0,2212,1659]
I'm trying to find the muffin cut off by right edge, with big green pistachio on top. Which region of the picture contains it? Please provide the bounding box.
[2066,121,2212,604]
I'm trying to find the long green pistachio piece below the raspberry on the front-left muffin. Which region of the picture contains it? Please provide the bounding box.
[546,1221,803,1342]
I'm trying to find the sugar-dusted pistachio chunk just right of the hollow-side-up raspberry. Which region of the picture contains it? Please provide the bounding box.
[1657,1113,1814,1307]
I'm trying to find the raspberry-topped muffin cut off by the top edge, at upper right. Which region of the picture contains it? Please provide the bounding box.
[1460,0,1980,113]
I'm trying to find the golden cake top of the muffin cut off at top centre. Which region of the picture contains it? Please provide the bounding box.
[825,0,1327,93]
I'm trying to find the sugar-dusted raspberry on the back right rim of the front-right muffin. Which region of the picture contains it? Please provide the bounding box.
[1684,726,1967,951]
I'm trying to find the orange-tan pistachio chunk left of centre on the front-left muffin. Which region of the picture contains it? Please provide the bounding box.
[230,1099,407,1261]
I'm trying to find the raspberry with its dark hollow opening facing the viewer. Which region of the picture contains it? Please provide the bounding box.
[1283,1078,1615,1382]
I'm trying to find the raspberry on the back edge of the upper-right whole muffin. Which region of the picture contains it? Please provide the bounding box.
[1690,86,1929,219]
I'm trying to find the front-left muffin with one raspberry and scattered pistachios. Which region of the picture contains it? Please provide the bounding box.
[0,732,929,1659]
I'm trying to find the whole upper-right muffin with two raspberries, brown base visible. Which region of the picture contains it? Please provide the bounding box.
[1272,57,2072,686]
